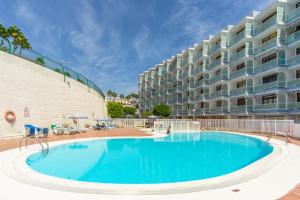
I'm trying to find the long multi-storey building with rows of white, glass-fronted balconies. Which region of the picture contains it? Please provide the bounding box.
[139,0,300,121]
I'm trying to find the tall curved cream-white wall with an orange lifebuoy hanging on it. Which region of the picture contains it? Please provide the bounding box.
[0,52,107,136]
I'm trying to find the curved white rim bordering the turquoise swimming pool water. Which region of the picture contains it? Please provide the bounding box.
[3,131,290,195]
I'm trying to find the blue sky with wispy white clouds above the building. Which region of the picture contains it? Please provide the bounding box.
[0,0,272,94]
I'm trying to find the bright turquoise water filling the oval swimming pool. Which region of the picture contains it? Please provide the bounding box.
[27,132,273,184]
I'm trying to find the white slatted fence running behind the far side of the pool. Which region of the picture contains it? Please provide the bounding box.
[113,118,294,137]
